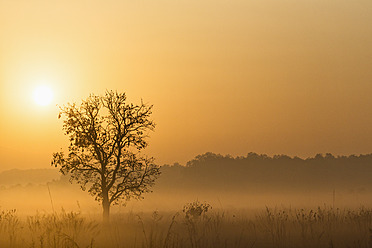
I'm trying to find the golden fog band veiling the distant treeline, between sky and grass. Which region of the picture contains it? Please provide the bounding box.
[0,153,372,215]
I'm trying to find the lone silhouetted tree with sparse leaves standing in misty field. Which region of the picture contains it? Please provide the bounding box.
[51,91,160,220]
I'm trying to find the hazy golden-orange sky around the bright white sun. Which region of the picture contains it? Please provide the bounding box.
[0,0,372,170]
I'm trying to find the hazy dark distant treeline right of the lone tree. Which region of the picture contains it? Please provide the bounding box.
[154,152,372,192]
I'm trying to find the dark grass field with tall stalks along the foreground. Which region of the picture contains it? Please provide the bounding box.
[0,206,372,248]
